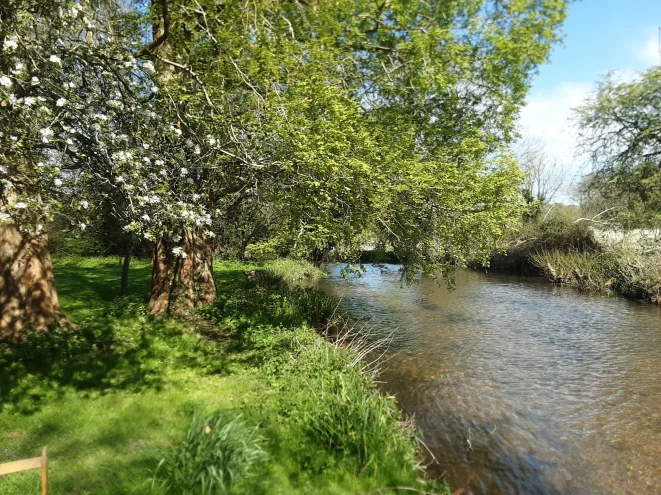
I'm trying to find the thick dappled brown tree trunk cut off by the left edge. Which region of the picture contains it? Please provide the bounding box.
[0,223,66,342]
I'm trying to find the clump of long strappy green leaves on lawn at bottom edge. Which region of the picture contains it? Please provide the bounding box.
[153,413,266,495]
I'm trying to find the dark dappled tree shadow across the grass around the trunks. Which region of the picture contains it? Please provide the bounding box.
[0,259,336,414]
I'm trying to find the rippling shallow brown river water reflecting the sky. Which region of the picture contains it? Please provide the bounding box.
[322,266,661,495]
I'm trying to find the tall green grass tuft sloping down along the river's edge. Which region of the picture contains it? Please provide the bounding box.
[268,330,420,483]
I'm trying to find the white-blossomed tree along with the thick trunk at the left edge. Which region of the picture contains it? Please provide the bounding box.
[0,0,214,340]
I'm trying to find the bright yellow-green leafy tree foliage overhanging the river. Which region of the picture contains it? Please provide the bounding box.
[146,0,566,280]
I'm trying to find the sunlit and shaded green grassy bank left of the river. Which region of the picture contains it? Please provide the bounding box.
[0,259,446,495]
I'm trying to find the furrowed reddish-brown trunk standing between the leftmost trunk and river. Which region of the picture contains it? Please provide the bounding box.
[149,231,216,316]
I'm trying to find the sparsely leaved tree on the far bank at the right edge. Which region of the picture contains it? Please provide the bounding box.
[575,66,661,226]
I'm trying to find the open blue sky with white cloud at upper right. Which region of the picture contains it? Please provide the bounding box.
[519,0,661,203]
